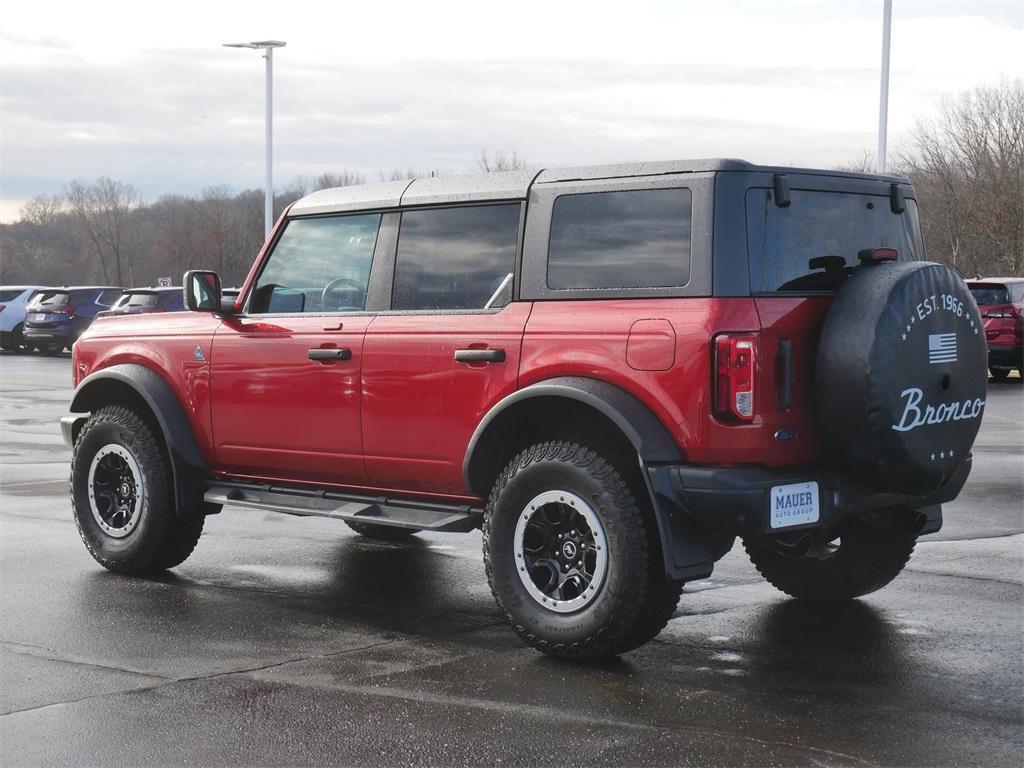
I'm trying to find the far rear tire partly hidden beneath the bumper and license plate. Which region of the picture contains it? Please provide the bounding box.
[743,517,918,603]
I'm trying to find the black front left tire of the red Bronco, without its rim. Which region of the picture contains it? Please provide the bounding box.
[71,406,205,573]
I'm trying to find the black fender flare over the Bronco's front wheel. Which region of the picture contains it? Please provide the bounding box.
[70,362,212,515]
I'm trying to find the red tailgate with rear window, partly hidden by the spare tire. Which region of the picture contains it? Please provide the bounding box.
[745,175,925,463]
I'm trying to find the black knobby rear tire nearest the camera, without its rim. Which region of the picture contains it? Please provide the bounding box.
[483,441,683,659]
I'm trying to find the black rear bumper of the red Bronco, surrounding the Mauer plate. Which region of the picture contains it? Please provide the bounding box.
[647,457,971,581]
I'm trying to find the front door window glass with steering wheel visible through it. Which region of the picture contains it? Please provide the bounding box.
[249,213,381,314]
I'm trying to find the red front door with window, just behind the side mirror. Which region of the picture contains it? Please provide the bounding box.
[211,214,381,484]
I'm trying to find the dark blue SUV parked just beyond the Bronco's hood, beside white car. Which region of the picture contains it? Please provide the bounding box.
[24,286,124,354]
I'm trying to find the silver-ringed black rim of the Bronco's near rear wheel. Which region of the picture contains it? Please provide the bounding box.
[514,490,608,613]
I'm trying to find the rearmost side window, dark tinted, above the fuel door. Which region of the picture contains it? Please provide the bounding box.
[548,189,691,288]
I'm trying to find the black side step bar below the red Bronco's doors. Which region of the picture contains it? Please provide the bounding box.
[203,481,482,532]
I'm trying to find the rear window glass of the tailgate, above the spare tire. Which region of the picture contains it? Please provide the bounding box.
[746,189,925,293]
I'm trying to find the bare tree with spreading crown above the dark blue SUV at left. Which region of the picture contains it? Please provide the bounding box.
[66,176,140,286]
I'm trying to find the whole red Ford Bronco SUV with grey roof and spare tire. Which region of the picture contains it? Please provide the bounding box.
[62,160,987,657]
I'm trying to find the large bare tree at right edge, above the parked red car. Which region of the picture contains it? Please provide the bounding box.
[900,79,1024,275]
